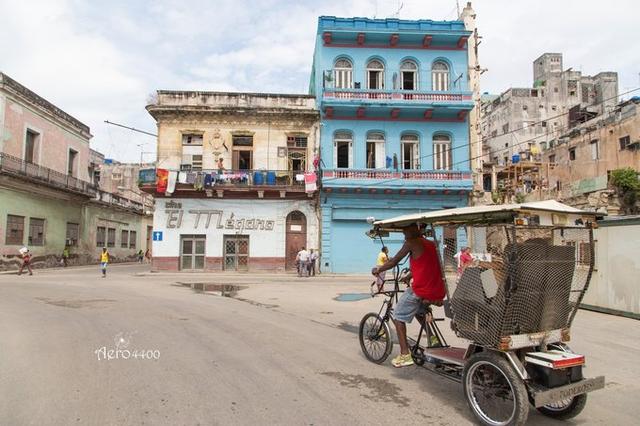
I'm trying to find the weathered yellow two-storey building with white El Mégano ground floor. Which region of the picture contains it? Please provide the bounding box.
[143,91,319,271]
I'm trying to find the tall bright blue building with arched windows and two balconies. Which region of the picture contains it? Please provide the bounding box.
[310,16,473,272]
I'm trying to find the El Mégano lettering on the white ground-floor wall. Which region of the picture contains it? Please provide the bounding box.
[165,201,275,232]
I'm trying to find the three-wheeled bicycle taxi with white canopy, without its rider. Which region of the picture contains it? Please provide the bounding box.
[359,201,604,425]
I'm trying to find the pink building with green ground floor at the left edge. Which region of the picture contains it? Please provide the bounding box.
[0,73,151,270]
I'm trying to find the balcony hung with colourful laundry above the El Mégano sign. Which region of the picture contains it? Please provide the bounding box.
[140,169,315,198]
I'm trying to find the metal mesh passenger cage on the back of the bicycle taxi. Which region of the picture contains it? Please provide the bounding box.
[447,226,593,347]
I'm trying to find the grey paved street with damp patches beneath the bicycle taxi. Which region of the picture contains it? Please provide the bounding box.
[0,265,640,425]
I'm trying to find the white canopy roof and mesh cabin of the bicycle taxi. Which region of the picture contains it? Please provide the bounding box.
[370,200,602,350]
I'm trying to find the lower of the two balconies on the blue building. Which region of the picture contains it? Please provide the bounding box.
[322,169,473,195]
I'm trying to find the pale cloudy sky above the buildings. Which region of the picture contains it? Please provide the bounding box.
[0,0,640,162]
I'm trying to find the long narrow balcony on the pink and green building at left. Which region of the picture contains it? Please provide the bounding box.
[0,152,96,197]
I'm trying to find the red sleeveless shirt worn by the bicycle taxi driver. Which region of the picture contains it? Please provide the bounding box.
[409,238,447,301]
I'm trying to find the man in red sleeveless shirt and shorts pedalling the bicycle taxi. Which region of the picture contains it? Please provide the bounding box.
[371,225,446,367]
